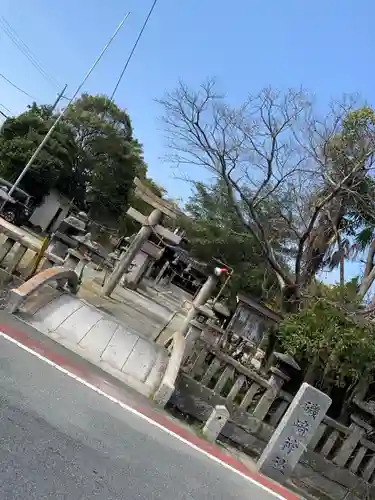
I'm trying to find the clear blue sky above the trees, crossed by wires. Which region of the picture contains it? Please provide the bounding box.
[0,0,375,284]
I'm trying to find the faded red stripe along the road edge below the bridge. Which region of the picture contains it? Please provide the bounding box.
[0,324,300,500]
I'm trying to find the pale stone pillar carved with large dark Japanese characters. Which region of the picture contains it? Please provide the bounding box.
[257,383,332,483]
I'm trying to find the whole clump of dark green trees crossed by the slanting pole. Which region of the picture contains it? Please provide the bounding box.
[0,94,147,226]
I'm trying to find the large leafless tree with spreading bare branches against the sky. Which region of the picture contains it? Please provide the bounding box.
[159,81,375,308]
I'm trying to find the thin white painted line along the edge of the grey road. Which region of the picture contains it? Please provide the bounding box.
[0,331,285,500]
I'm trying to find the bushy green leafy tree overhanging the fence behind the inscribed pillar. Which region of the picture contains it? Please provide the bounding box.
[278,282,375,389]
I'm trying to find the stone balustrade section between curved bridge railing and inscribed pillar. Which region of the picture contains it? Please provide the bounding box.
[177,337,289,435]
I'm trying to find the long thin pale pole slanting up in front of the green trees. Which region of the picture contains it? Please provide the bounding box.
[0,12,130,211]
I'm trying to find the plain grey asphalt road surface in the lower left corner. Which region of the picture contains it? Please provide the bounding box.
[0,332,288,500]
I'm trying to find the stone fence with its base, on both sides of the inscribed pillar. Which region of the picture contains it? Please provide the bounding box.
[170,335,375,500]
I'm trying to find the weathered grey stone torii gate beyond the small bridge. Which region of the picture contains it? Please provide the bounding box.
[102,178,182,297]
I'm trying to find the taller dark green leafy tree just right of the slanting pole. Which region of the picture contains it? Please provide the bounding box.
[65,94,146,224]
